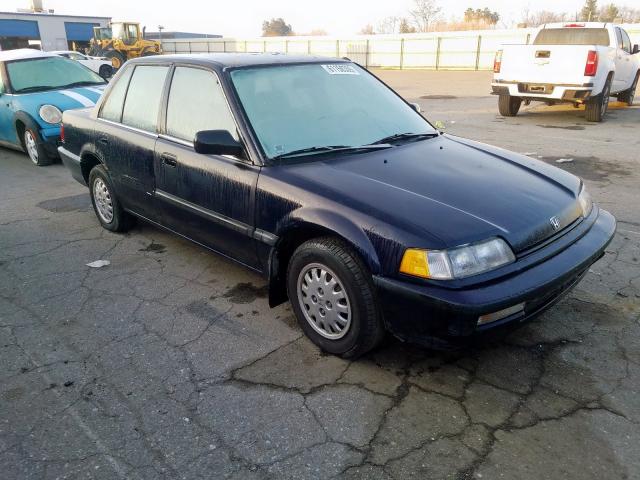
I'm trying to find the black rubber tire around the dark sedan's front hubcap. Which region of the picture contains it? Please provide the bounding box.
[287,237,385,358]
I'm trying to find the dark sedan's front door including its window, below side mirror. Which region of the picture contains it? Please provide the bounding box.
[155,65,259,268]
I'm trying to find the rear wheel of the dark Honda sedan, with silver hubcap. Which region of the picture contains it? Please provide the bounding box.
[89,165,135,232]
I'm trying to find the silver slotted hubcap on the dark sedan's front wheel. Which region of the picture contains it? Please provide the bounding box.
[298,263,351,340]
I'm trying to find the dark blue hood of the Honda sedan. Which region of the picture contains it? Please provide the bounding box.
[278,135,581,252]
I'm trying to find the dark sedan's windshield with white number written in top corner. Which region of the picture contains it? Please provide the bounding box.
[231,63,437,158]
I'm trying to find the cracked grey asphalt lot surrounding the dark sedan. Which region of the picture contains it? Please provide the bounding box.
[0,72,640,480]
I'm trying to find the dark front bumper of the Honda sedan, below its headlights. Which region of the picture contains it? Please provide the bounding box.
[374,207,616,348]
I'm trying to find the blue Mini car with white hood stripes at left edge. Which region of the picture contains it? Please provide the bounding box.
[0,49,106,166]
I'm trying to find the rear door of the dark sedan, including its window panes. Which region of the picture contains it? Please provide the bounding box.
[95,65,169,220]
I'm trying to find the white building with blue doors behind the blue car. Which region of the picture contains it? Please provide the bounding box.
[0,12,111,50]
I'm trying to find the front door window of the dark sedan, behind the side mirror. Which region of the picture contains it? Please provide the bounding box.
[167,67,238,142]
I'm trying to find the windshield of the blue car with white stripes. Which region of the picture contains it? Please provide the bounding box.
[7,56,105,93]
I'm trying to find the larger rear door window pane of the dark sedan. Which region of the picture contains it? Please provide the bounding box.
[122,65,169,132]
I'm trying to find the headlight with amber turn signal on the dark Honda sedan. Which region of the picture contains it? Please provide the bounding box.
[400,238,516,280]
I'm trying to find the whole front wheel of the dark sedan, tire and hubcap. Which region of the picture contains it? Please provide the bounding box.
[287,237,384,358]
